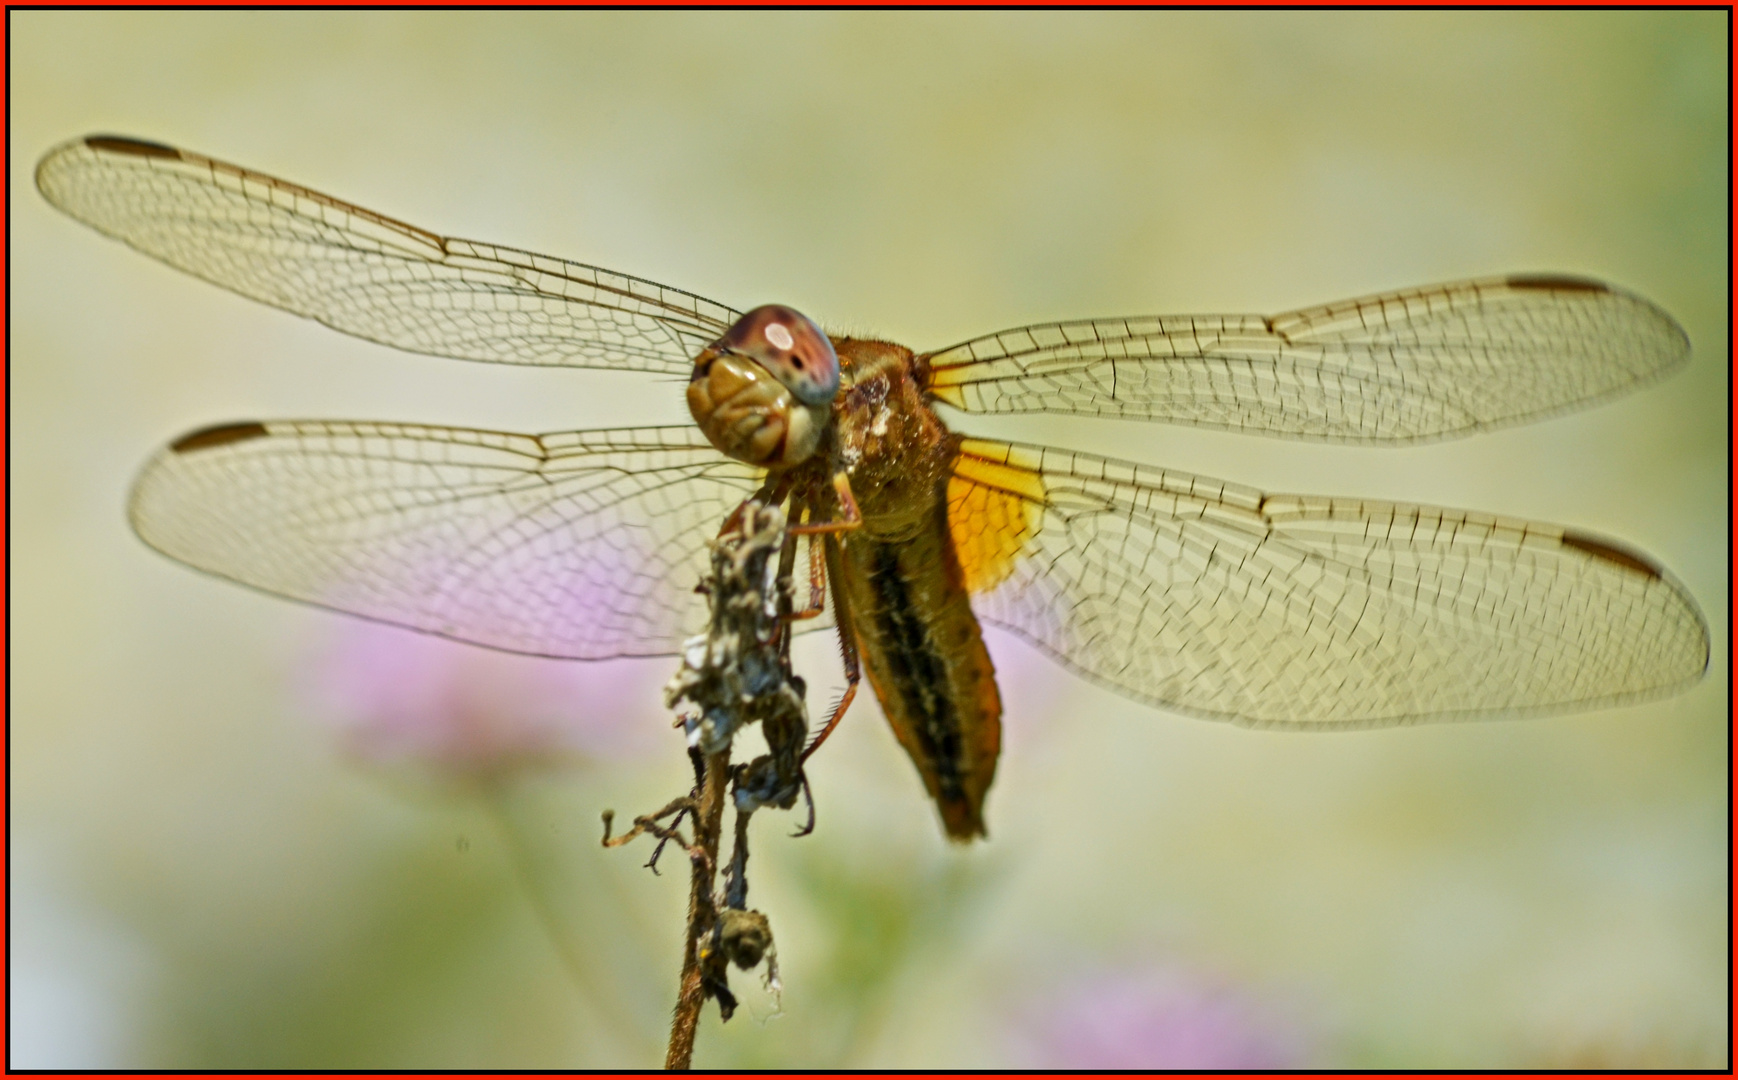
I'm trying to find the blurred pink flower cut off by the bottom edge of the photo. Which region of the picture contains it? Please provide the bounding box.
[1012,965,1312,1070]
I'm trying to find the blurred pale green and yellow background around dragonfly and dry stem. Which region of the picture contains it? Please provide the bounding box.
[9,10,1729,1068]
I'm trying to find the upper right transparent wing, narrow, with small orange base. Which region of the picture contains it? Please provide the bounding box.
[928,275,1689,443]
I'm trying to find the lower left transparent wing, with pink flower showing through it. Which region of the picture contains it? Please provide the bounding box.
[130,421,782,659]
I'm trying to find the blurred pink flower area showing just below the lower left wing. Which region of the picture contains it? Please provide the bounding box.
[299,619,676,777]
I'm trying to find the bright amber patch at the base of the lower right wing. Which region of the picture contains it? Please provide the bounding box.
[947,438,1045,593]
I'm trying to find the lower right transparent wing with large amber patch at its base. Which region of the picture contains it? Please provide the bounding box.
[949,440,1708,727]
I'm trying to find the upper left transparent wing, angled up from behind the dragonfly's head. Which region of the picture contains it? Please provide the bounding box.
[36,136,737,376]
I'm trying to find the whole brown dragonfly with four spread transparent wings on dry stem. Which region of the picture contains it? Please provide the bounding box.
[36,136,1708,840]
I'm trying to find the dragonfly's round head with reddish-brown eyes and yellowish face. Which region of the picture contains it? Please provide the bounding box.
[688,304,839,468]
